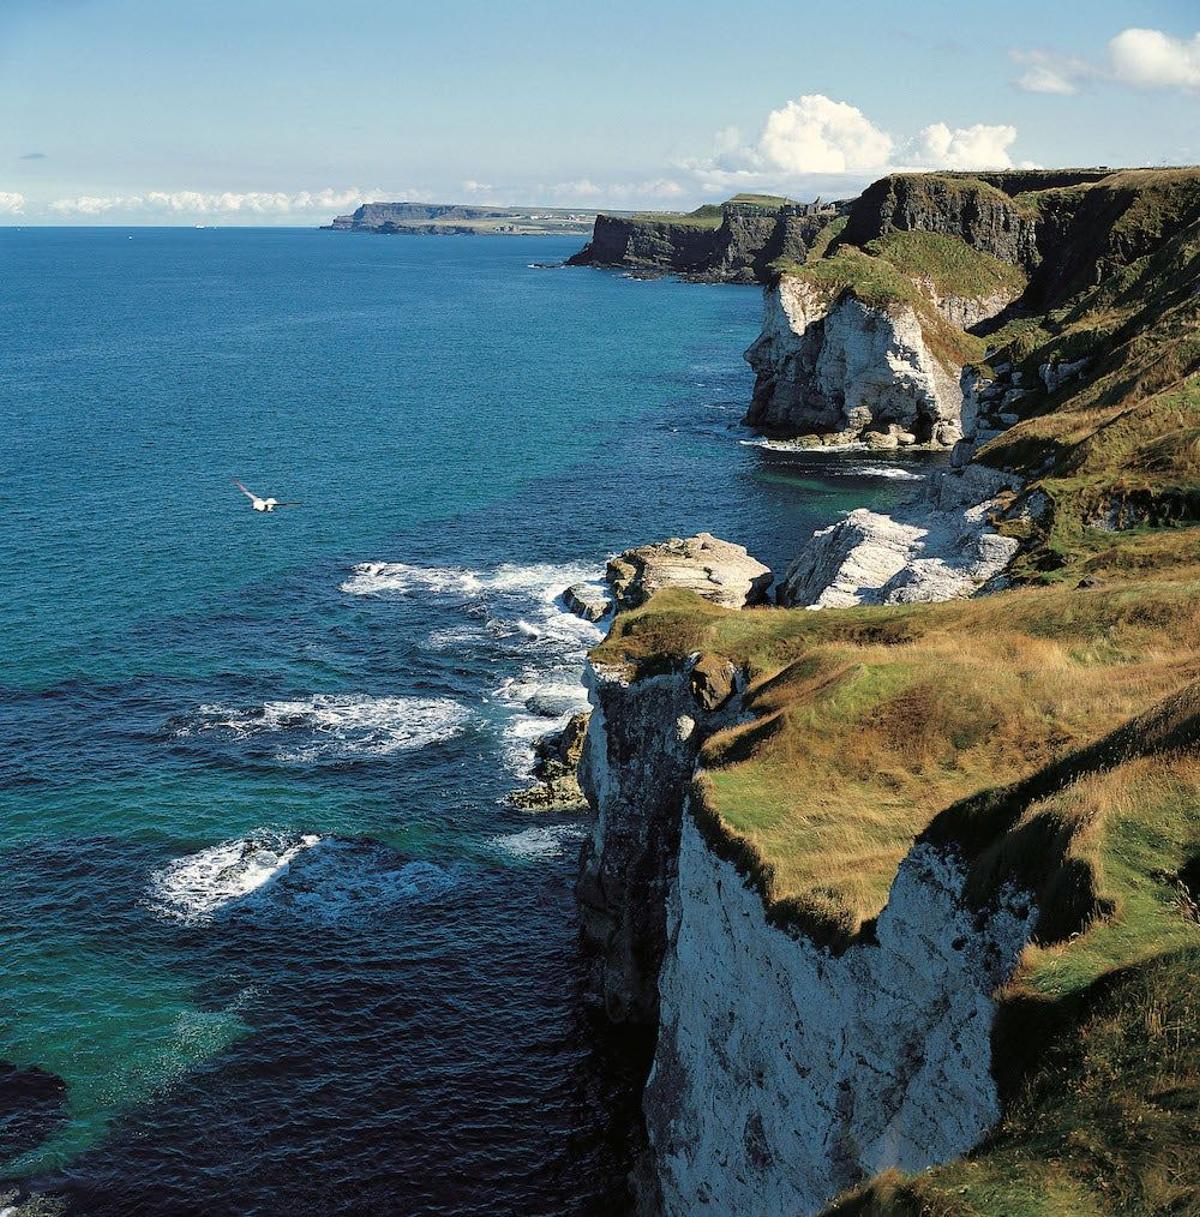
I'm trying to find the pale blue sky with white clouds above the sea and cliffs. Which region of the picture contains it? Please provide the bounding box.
[0,0,1200,225]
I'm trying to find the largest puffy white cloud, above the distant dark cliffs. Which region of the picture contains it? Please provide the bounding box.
[757,92,892,174]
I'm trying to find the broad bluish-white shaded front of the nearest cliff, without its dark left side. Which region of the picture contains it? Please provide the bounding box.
[644,812,1034,1217]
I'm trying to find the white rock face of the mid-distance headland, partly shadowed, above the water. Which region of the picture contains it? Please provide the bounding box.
[746,275,963,447]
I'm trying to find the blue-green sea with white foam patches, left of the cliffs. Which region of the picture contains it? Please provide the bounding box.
[0,229,920,1217]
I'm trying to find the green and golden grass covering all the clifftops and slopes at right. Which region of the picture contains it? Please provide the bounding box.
[596,166,1200,1217]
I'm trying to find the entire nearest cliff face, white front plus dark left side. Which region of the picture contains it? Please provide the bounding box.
[579,657,1036,1217]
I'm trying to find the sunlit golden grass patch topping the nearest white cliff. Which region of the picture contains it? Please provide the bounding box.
[595,577,1200,947]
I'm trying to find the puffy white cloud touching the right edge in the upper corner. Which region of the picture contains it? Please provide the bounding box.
[1013,28,1200,94]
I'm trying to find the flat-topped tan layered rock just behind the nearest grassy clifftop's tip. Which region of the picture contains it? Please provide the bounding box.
[605,533,774,610]
